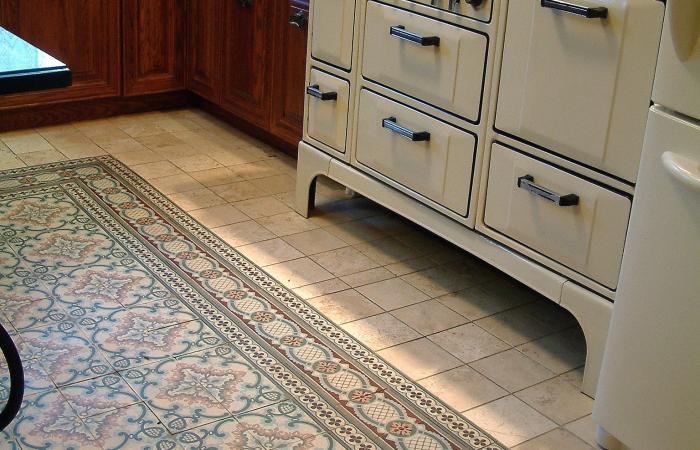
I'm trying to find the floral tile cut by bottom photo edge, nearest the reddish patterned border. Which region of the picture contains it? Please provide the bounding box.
[178,402,343,450]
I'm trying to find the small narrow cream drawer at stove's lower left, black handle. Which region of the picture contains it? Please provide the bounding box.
[306,69,350,153]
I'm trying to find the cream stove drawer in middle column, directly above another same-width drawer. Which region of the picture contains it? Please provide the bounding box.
[362,2,488,122]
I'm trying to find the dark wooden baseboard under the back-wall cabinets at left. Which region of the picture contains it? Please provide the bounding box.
[0,90,194,131]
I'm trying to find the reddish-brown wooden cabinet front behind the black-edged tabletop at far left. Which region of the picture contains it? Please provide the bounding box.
[0,0,121,107]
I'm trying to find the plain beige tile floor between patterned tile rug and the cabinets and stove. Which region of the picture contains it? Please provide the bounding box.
[0,109,595,450]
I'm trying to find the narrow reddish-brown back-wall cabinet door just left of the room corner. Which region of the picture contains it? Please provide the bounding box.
[122,0,185,95]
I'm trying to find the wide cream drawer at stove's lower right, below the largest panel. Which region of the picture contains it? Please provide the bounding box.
[484,144,631,289]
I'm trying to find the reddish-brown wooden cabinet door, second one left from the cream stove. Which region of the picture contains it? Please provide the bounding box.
[221,0,275,128]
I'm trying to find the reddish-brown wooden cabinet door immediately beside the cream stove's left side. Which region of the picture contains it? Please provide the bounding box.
[270,0,309,145]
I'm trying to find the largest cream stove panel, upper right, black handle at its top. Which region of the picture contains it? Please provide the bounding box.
[496,0,664,181]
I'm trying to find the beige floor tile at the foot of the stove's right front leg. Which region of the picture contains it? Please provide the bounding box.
[515,377,593,425]
